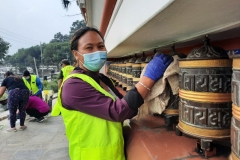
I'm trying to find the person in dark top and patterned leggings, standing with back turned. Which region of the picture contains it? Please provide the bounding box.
[0,71,30,132]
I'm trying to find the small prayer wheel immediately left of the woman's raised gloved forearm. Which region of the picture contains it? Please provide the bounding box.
[132,52,146,86]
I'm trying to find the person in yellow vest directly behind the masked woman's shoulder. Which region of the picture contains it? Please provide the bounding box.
[58,59,74,89]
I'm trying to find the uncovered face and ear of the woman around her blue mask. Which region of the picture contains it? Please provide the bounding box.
[73,31,106,69]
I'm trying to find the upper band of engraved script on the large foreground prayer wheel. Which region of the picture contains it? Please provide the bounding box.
[179,72,231,93]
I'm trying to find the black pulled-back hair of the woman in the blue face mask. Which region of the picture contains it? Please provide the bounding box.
[71,27,104,50]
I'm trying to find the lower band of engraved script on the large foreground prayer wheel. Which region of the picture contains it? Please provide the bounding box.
[179,101,231,128]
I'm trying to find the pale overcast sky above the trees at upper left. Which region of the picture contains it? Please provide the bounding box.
[0,0,83,55]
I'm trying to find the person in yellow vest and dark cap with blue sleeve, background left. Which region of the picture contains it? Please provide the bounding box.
[23,70,43,99]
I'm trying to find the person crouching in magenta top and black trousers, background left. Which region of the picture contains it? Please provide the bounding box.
[26,96,50,123]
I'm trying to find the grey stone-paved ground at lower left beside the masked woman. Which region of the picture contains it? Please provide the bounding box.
[0,97,69,160]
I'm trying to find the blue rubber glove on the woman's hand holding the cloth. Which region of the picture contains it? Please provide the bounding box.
[144,54,173,82]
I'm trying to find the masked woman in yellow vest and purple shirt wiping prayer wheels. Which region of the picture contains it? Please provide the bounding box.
[52,27,172,160]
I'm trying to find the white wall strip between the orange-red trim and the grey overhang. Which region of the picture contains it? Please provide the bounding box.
[105,0,174,52]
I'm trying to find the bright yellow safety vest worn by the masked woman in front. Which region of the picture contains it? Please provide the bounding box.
[52,74,125,160]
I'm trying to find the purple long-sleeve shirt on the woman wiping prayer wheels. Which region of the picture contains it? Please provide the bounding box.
[61,68,143,122]
